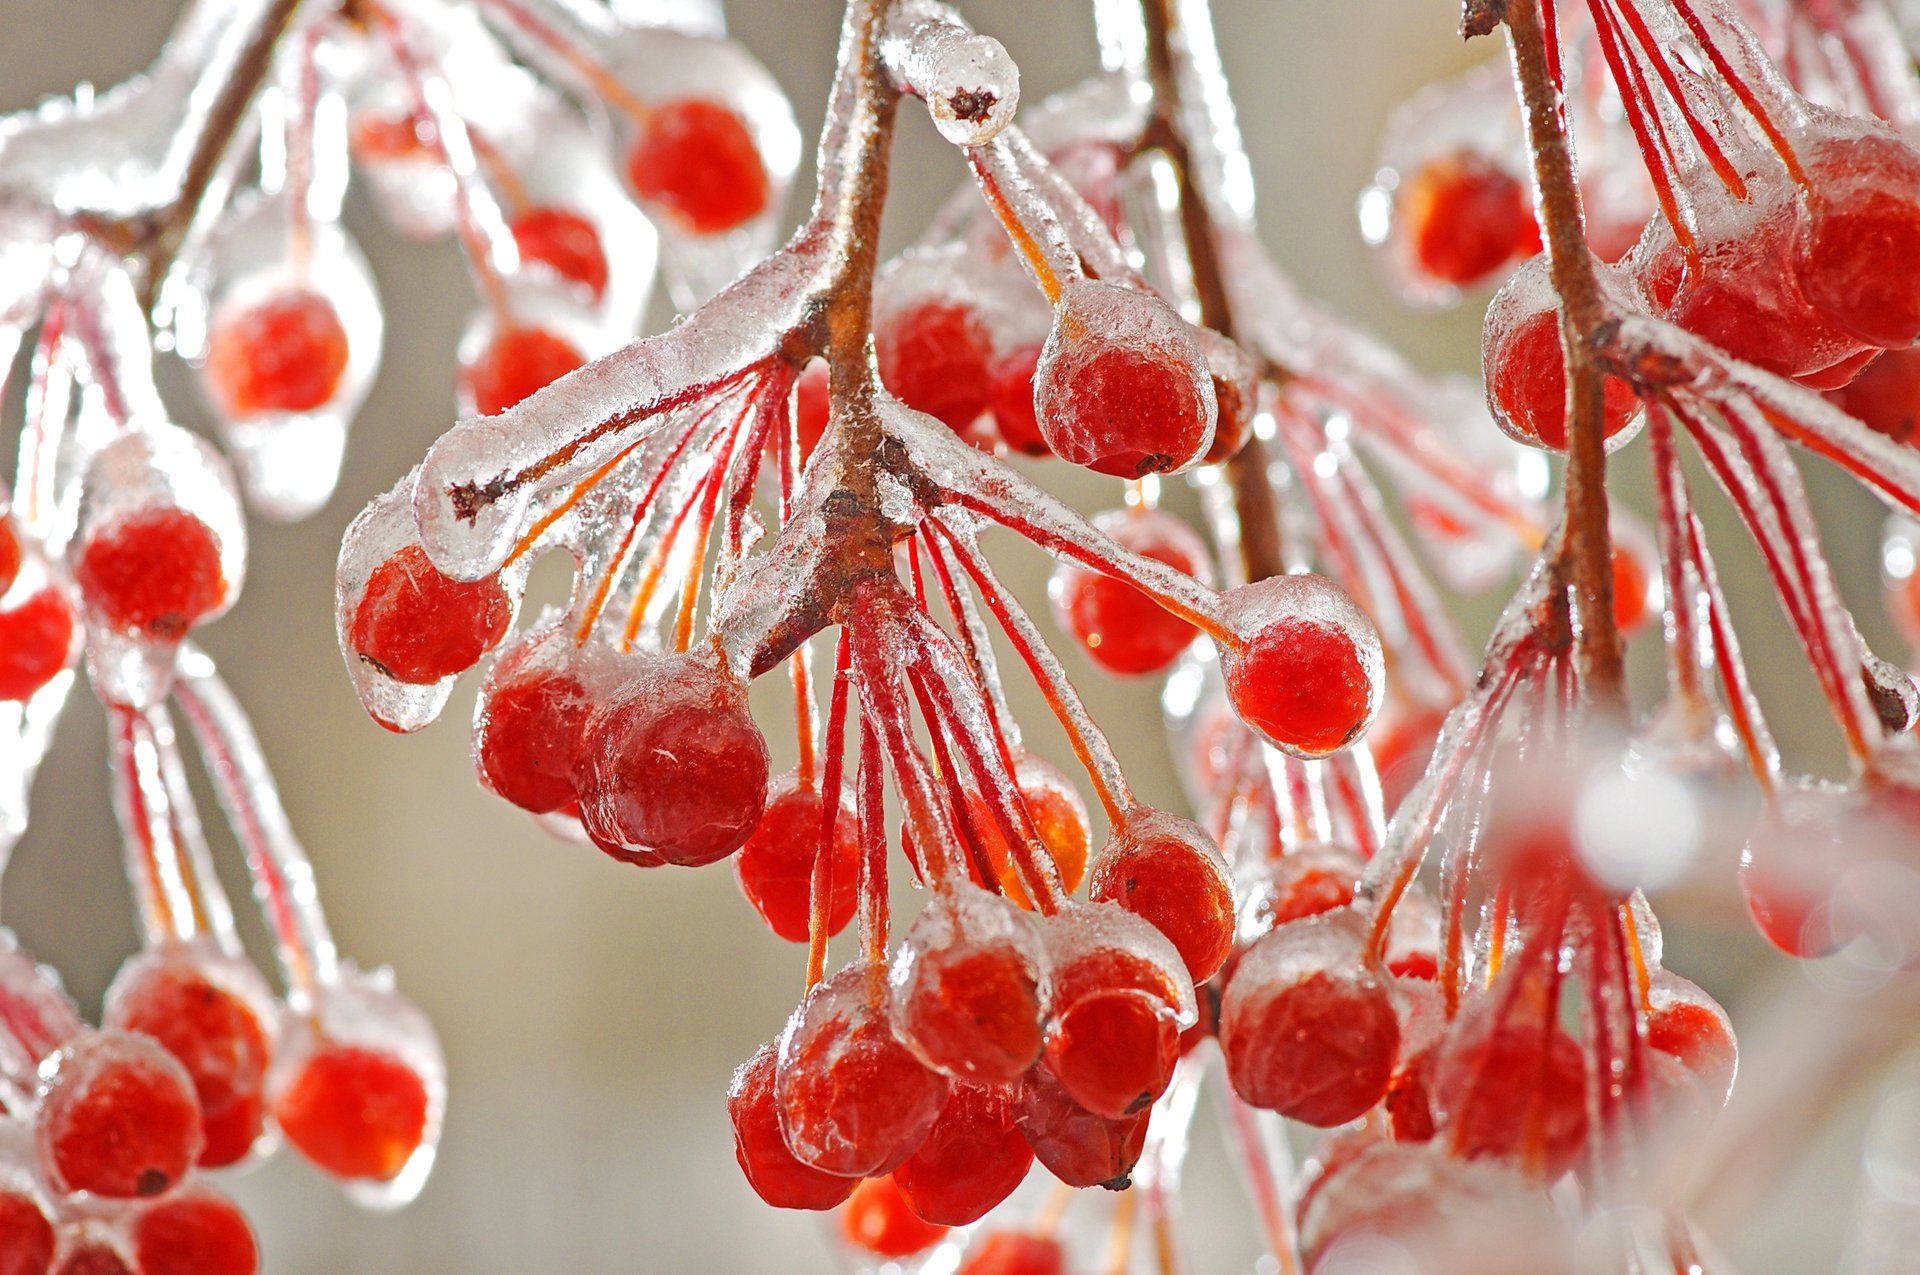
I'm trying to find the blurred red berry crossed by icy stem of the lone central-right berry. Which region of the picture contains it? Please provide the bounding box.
[1048,509,1212,676]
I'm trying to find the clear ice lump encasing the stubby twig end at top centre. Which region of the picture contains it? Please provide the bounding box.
[879,0,1020,146]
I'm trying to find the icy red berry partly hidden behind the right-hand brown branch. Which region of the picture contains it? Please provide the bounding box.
[1480,286,1640,451]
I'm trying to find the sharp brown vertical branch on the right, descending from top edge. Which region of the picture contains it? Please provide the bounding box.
[1482,0,1626,709]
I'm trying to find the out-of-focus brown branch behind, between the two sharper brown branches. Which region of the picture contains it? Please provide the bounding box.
[1140,0,1286,582]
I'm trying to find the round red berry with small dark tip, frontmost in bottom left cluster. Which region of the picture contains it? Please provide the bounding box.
[35,1031,204,1200]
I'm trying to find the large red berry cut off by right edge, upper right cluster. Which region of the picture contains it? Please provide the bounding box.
[1793,129,1920,349]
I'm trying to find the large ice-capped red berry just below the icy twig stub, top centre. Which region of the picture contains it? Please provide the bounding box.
[1033,282,1217,478]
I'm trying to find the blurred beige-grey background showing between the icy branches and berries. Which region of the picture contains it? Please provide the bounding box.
[0,0,1914,1275]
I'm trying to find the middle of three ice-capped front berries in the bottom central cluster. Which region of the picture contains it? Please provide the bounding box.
[891,887,1046,1083]
